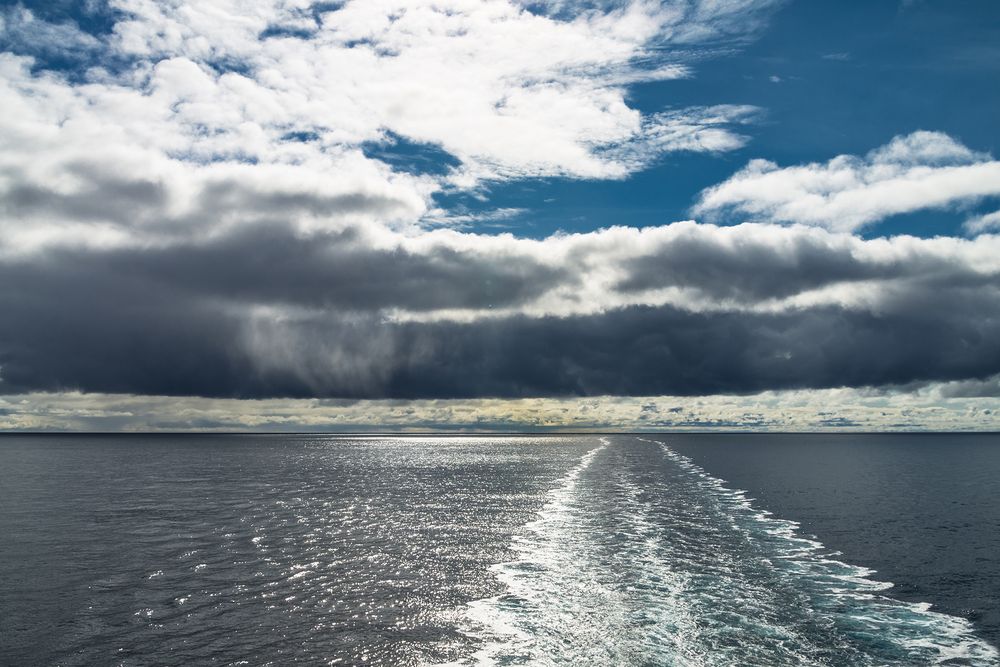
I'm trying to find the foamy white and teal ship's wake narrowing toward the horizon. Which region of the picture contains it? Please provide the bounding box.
[456,438,1000,665]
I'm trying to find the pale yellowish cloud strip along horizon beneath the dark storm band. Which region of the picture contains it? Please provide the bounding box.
[0,378,1000,432]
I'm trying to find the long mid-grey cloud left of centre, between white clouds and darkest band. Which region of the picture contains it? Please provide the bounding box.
[19,223,575,312]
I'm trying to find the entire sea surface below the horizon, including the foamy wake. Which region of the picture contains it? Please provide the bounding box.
[0,435,1000,665]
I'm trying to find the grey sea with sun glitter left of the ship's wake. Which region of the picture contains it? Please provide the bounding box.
[0,436,593,666]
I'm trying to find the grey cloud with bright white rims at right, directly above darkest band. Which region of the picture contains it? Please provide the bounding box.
[616,223,1000,309]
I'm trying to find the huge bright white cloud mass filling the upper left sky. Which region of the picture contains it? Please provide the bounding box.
[0,0,776,253]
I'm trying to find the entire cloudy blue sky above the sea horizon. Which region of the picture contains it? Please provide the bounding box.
[0,0,1000,431]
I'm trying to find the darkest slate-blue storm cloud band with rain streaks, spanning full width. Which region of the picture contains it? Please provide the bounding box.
[0,238,1000,398]
